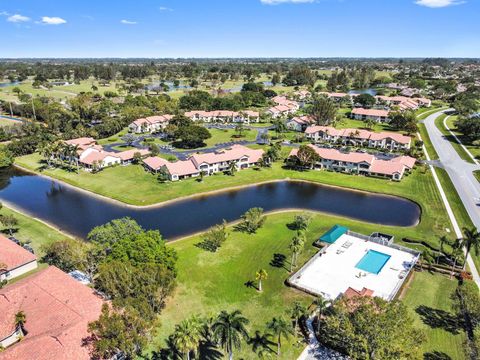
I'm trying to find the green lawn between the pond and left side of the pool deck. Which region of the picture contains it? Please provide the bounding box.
[156,212,434,359]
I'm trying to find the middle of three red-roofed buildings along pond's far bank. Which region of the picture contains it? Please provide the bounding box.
[144,145,263,181]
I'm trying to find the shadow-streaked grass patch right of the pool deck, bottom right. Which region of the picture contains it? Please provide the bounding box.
[402,271,466,360]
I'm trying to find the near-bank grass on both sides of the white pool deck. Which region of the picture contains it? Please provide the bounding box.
[152,212,465,360]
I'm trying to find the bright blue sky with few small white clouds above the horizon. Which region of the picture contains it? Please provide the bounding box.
[0,0,480,58]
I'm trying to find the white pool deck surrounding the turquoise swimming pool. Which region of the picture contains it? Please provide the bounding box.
[289,234,418,300]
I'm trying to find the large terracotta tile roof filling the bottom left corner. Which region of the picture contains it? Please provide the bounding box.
[0,266,103,360]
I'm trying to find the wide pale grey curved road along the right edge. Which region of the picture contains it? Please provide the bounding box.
[424,109,480,284]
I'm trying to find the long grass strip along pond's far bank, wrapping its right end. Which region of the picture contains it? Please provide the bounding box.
[16,153,453,252]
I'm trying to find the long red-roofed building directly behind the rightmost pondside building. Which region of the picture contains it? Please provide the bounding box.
[305,126,412,150]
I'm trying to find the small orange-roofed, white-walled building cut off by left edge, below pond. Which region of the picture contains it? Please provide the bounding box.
[0,235,37,281]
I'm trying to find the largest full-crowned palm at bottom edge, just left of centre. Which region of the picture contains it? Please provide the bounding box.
[212,310,249,360]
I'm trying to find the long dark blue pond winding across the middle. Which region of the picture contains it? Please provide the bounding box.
[0,168,420,239]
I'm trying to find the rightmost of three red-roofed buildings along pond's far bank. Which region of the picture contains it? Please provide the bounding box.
[290,145,416,180]
